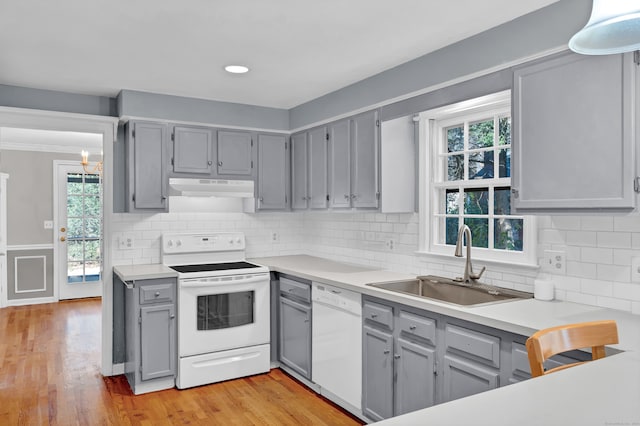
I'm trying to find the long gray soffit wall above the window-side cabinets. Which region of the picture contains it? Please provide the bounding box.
[289,0,591,129]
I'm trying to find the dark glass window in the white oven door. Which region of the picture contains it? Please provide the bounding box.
[197,291,255,330]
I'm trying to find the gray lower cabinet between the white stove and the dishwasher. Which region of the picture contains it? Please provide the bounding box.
[279,275,311,380]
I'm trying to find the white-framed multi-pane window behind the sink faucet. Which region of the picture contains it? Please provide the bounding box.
[422,92,535,264]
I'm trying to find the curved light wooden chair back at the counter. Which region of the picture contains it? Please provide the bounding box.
[527,320,618,377]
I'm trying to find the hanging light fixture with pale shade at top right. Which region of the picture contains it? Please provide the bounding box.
[569,0,640,55]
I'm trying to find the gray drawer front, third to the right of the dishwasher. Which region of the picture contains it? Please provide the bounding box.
[445,324,500,367]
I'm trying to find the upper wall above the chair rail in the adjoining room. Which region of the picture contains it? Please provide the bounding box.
[0,150,80,245]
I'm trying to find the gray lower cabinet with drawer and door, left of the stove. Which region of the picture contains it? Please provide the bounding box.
[124,278,177,395]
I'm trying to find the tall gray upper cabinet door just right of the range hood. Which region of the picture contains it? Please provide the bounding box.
[258,135,289,210]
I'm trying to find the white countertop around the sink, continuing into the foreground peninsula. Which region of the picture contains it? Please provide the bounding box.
[251,255,640,426]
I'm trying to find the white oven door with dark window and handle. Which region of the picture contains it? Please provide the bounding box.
[178,273,270,358]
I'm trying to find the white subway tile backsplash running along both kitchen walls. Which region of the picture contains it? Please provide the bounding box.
[112,212,640,314]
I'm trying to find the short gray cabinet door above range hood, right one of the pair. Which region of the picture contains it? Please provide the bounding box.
[218,131,253,176]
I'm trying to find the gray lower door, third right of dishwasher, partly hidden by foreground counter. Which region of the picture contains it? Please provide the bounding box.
[440,355,500,402]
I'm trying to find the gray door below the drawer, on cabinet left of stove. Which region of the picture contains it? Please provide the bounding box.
[140,304,177,380]
